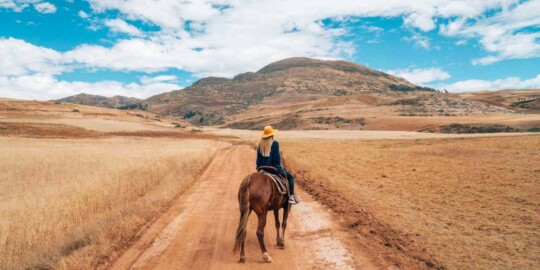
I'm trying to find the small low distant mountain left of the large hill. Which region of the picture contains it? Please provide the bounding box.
[55,93,141,108]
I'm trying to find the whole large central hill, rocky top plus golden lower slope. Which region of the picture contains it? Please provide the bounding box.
[142,58,538,130]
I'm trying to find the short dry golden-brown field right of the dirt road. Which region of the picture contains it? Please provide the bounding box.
[282,136,540,269]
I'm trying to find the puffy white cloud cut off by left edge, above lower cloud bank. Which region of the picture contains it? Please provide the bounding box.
[0,38,67,76]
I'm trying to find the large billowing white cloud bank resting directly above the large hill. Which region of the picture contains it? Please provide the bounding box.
[66,23,350,76]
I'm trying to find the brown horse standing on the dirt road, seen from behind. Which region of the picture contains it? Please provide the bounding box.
[233,173,290,263]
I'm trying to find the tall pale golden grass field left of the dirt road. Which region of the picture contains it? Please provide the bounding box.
[0,137,227,269]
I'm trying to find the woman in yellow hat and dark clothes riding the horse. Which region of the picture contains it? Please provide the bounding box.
[257,126,298,204]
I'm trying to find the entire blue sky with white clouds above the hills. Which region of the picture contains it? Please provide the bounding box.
[0,0,540,100]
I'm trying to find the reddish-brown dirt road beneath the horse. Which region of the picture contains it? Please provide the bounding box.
[112,145,377,269]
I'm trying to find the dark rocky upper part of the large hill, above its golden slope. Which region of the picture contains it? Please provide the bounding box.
[143,58,432,125]
